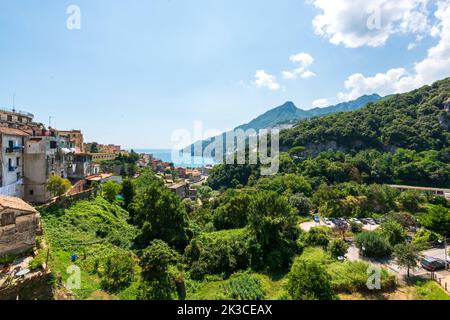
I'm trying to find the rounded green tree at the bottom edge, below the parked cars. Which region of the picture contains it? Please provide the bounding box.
[287,259,336,300]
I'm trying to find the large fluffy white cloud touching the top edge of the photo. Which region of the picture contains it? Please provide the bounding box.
[312,0,431,48]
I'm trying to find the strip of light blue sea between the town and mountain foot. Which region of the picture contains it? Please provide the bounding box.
[134,149,215,168]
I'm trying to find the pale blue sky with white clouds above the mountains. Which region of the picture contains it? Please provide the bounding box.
[0,0,450,148]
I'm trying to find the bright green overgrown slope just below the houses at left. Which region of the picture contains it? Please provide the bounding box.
[36,197,140,299]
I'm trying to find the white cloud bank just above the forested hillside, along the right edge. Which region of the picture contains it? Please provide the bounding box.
[338,0,450,100]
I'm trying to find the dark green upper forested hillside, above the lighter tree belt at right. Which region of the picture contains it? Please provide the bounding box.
[281,78,450,153]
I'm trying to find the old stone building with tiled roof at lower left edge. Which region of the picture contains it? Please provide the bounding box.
[0,195,40,256]
